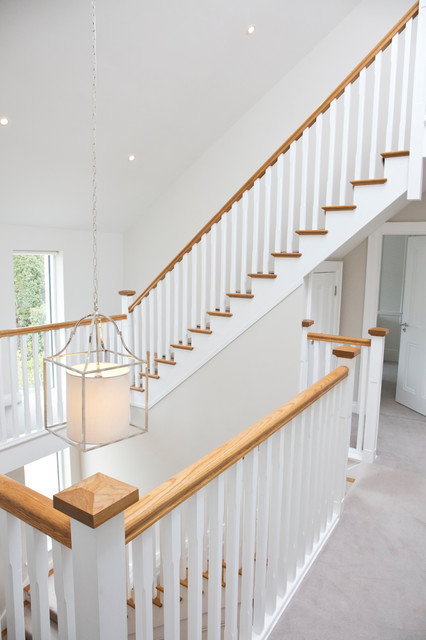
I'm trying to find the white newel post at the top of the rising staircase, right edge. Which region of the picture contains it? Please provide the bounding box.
[407,0,426,200]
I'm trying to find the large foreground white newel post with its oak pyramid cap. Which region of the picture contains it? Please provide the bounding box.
[53,473,139,640]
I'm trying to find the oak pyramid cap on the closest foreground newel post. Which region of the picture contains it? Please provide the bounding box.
[53,473,139,529]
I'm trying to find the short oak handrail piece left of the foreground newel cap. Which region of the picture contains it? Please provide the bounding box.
[0,474,71,549]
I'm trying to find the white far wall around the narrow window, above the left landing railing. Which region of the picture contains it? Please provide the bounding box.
[0,225,123,329]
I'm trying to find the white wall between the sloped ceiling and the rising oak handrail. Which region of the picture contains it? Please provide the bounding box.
[125,0,412,291]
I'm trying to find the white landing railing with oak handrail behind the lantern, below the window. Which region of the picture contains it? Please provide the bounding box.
[0,314,127,450]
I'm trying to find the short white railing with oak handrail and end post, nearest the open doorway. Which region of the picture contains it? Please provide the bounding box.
[302,328,389,462]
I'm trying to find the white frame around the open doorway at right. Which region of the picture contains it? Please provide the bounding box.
[362,221,426,336]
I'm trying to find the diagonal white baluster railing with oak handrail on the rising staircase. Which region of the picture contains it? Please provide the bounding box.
[129,3,420,386]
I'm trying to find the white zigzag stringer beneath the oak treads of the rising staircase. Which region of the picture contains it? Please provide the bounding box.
[132,157,408,407]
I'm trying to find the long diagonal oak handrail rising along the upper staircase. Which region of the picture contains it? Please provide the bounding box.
[129,2,419,313]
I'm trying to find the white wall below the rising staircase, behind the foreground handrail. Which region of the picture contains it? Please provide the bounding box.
[82,287,303,494]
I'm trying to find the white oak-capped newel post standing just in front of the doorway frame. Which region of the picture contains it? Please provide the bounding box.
[363,327,389,462]
